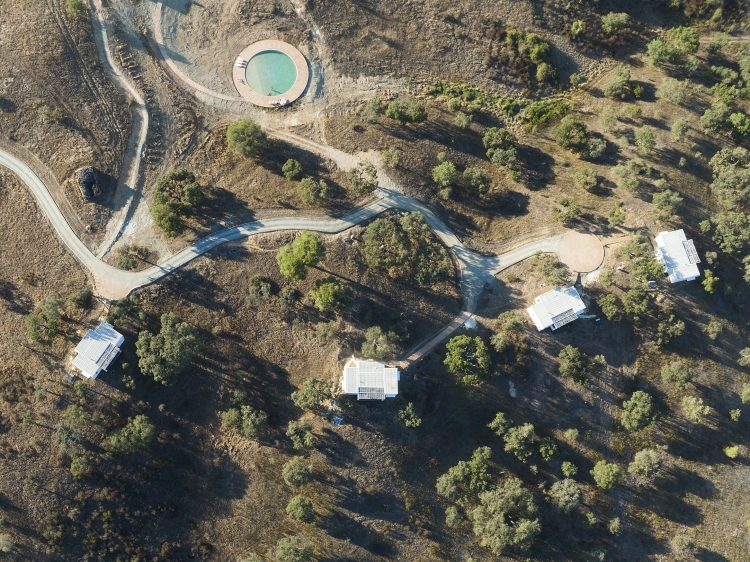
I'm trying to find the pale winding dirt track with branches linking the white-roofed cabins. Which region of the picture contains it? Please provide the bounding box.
[0,0,562,367]
